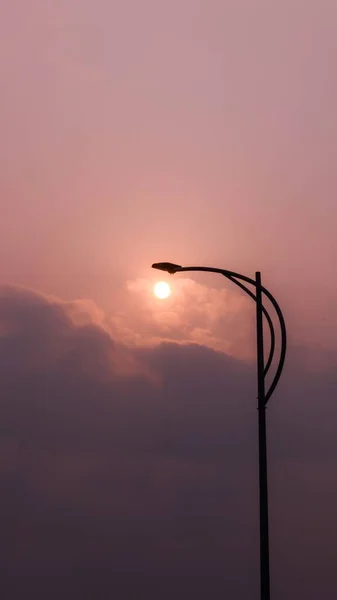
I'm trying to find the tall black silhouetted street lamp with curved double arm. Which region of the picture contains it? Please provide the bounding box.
[152,262,287,600]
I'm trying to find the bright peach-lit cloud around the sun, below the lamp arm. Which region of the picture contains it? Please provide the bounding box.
[111,277,255,359]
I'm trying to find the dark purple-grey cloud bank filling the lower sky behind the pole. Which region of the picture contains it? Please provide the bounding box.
[0,288,337,600]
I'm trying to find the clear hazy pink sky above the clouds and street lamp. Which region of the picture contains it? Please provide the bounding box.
[0,0,337,354]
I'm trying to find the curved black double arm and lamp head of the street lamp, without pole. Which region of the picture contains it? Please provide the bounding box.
[152,262,287,404]
